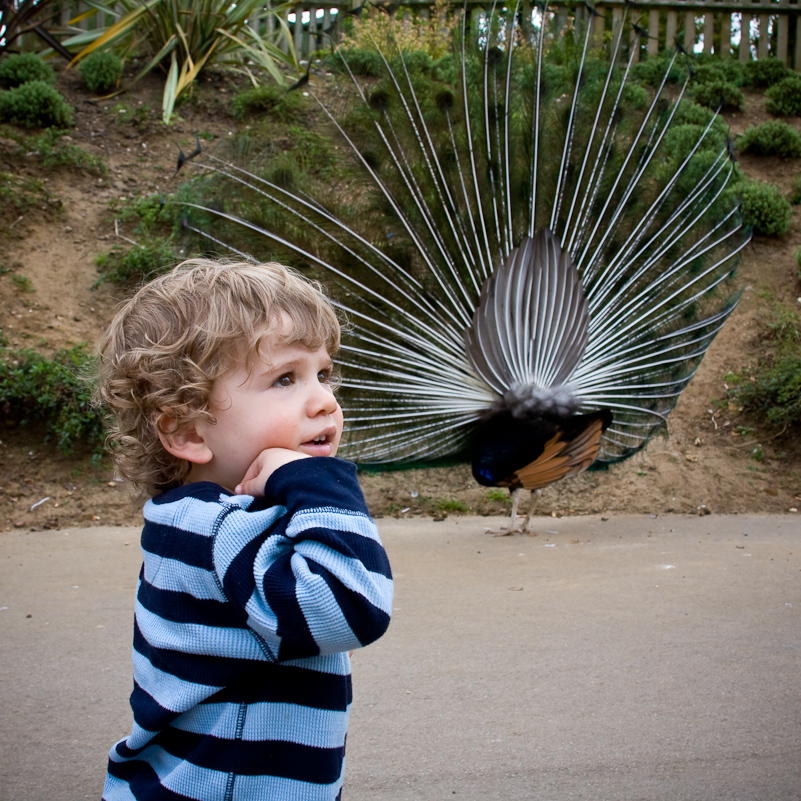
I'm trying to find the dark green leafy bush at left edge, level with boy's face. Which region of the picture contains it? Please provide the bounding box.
[0,344,104,453]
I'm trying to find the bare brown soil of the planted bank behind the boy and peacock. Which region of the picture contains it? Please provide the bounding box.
[0,70,801,531]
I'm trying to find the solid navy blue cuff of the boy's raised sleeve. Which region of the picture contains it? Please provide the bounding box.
[264,456,369,514]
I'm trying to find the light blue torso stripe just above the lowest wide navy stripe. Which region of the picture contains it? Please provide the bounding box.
[172,702,349,748]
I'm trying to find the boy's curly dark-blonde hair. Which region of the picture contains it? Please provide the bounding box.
[97,259,340,496]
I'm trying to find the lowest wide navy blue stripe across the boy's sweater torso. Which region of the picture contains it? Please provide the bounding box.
[153,729,345,784]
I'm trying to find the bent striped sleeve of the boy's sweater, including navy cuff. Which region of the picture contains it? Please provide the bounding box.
[209,457,392,661]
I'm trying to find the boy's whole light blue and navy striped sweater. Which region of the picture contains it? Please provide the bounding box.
[103,458,392,801]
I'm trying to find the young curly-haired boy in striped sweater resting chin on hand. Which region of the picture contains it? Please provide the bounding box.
[99,260,392,801]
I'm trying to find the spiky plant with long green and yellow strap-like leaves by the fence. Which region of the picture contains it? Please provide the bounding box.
[65,0,297,123]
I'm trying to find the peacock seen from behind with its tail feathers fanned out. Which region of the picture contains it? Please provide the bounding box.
[178,3,749,530]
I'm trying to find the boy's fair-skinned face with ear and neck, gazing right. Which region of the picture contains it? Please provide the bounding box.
[188,337,343,490]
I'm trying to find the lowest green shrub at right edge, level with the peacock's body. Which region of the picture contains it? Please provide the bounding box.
[727,305,801,427]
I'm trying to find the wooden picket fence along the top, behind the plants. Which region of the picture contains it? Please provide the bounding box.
[10,0,801,72]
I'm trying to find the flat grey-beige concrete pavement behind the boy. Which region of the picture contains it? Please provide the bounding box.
[0,515,801,801]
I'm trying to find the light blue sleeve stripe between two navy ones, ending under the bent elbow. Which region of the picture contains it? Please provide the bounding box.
[292,553,361,654]
